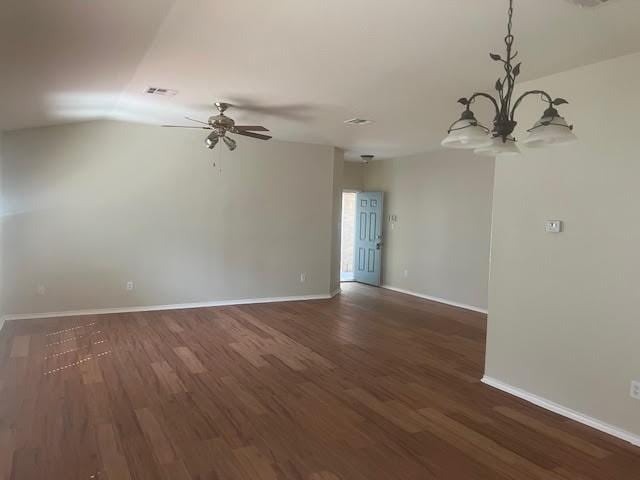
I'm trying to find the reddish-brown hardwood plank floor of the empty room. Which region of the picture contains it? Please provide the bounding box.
[0,284,640,480]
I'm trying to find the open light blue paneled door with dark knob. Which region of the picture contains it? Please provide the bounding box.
[353,192,383,286]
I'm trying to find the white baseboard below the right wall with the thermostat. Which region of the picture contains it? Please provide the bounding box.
[482,375,640,447]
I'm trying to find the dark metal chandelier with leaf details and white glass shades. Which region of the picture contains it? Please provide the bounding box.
[442,0,577,156]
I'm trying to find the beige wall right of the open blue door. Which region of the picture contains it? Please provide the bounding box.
[365,151,494,309]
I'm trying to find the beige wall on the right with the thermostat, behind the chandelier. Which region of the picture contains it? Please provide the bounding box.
[486,55,640,435]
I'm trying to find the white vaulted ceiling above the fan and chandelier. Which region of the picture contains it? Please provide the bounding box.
[0,0,640,157]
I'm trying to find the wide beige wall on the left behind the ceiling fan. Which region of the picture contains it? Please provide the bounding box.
[2,122,339,314]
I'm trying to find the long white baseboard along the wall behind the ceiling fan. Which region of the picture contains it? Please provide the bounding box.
[0,289,340,326]
